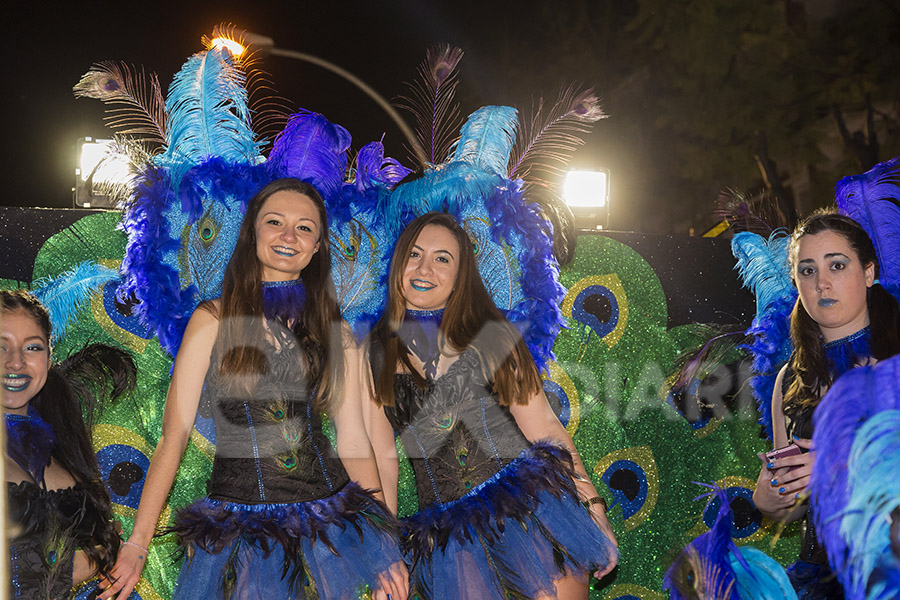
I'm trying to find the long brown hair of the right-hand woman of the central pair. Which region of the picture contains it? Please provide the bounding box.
[369,212,541,406]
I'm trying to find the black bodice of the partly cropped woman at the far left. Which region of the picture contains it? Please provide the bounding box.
[6,481,100,598]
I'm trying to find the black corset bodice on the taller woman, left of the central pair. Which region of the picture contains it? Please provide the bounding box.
[200,320,349,504]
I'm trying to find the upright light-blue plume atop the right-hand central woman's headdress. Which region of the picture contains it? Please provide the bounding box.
[450,106,519,177]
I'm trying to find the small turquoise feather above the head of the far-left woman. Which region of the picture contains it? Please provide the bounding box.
[33,261,118,340]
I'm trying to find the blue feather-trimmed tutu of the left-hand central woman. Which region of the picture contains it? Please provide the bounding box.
[171,483,402,600]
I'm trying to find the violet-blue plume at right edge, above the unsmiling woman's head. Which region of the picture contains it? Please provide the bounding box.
[834,157,900,288]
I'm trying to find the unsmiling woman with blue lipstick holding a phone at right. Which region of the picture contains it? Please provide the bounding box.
[753,212,900,598]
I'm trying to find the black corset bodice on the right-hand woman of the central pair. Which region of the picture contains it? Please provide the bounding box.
[385,349,530,507]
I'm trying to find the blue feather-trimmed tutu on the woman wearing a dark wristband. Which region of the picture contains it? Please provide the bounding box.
[403,443,617,600]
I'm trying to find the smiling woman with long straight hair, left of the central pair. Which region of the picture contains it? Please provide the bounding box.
[100,179,406,600]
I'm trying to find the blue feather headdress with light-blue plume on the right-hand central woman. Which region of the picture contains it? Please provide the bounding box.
[382,106,565,368]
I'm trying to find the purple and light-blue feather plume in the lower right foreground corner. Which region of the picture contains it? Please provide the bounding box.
[809,356,900,598]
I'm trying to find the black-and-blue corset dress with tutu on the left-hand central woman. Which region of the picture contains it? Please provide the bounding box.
[171,320,402,600]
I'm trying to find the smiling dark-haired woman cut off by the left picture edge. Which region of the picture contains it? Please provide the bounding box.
[0,290,135,599]
